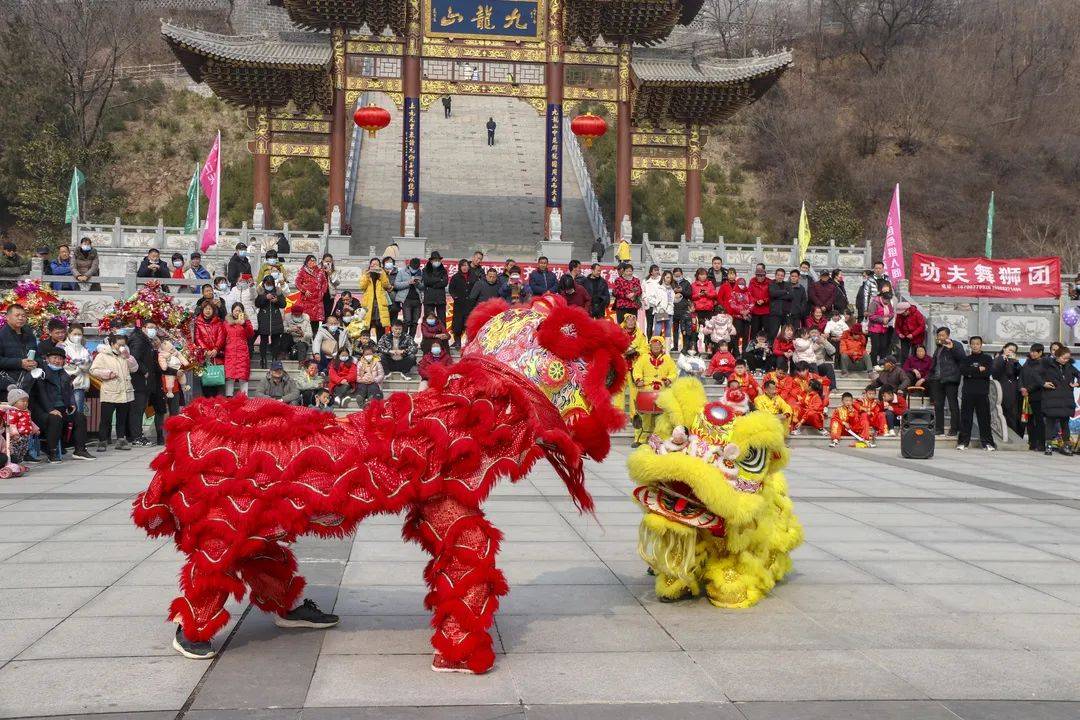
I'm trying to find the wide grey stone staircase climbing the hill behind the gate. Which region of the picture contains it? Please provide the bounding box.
[350,94,593,262]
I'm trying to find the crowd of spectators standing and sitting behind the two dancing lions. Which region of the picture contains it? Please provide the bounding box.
[0,240,1078,460]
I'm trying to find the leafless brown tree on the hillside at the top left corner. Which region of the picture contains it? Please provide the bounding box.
[17,0,144,148]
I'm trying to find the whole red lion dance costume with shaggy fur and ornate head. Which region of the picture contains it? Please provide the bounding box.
[132,295,626,673]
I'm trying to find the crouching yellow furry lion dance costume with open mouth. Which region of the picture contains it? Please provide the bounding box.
[627,378,802,608]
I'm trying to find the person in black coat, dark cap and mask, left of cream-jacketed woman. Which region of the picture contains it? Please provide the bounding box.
[30,348,93,463]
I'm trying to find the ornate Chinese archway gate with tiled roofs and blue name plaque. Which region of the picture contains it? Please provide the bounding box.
[162,0,792,239]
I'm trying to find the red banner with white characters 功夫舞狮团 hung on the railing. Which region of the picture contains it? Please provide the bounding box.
[909,253,1062,298]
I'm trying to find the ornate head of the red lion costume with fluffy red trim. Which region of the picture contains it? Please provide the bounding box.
[461,295,630,460]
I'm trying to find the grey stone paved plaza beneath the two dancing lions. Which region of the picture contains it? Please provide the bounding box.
[0,448,1080,720]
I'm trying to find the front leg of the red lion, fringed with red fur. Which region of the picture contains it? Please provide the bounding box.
[404,495,509,674]
